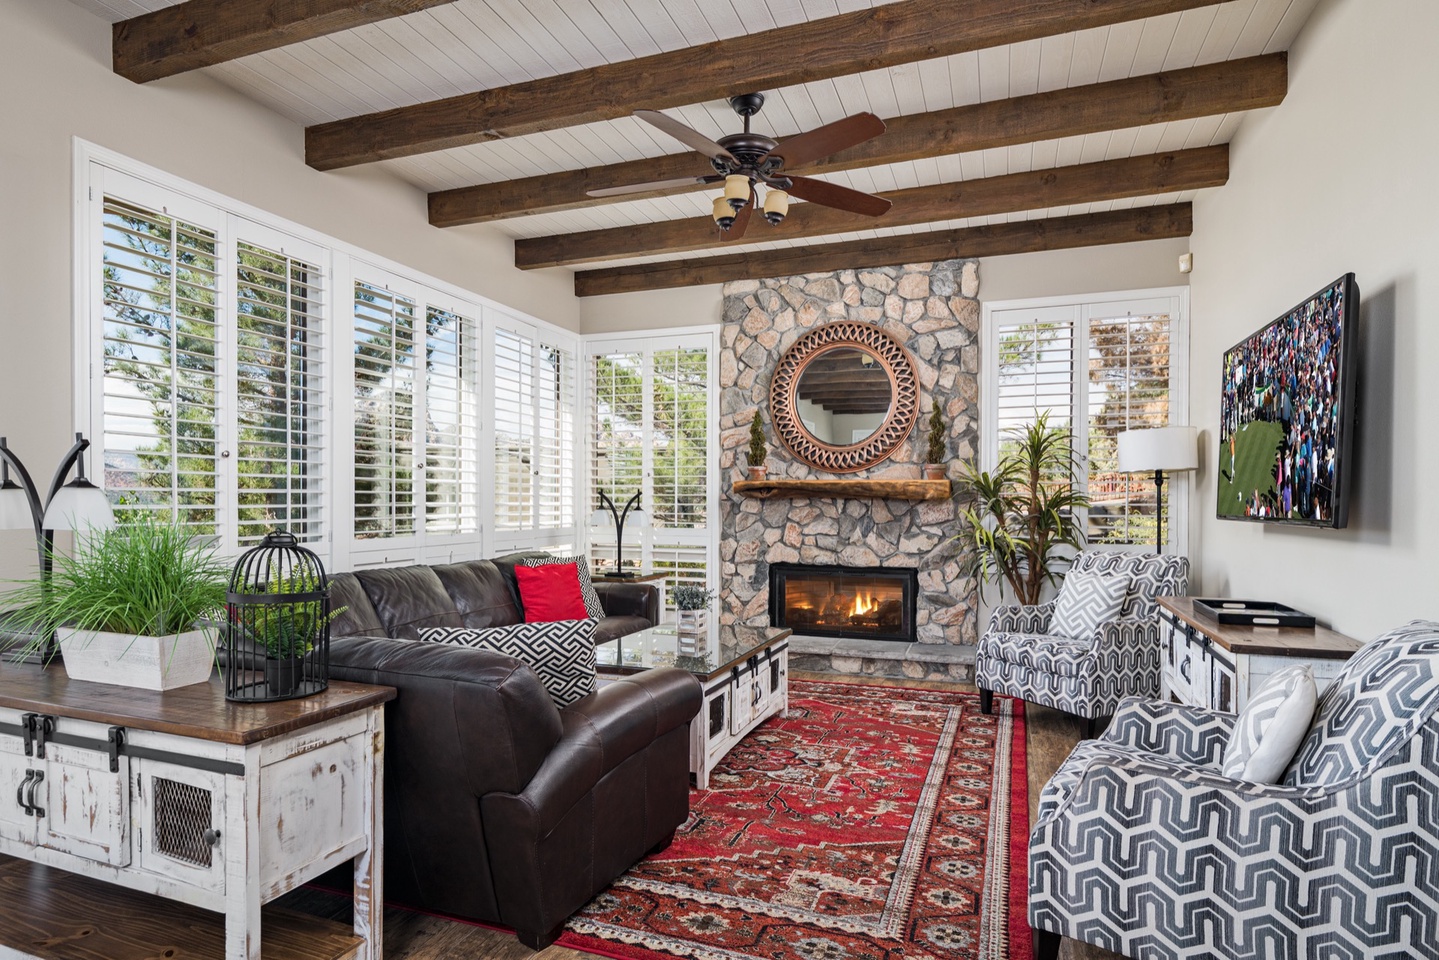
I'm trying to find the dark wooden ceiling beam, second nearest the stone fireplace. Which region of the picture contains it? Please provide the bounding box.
[515,144,1229,269]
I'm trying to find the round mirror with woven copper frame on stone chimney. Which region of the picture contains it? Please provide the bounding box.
[770,320,920,474]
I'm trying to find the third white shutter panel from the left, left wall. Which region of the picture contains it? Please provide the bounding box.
[353,281,416,540]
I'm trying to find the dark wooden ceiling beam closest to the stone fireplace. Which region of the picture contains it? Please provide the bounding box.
[574,203,1194,296]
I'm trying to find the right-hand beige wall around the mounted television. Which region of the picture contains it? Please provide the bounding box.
[1190,0,1439,639]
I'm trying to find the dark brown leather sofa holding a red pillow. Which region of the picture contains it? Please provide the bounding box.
[330,554,699,950]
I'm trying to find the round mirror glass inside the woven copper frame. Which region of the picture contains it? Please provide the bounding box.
[794,345,894,446]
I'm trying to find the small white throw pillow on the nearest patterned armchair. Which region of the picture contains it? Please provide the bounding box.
[1220,664,1320,783]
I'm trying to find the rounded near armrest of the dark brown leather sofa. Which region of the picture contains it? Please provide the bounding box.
[518,666,702,836]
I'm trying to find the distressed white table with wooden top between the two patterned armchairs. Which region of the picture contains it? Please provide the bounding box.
[1160,597,1361,714]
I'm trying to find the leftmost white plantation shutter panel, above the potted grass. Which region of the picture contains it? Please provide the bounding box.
[101,197,220,534]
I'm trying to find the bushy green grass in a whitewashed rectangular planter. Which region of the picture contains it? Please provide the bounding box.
[4,514,229,691]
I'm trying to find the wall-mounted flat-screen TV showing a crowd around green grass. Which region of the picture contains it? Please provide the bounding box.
[1217,273,1358,527]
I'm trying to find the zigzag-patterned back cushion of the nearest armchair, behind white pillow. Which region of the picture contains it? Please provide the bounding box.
[1284,620,1439,786]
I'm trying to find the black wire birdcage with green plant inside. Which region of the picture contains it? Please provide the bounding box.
[224,530,330,704]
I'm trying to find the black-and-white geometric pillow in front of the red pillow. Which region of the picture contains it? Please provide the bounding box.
[420,620,596,708]
